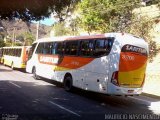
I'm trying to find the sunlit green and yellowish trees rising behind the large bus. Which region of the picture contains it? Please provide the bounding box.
[53,0,160,62]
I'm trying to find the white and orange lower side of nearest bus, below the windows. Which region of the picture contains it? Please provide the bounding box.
[30,54,109,93]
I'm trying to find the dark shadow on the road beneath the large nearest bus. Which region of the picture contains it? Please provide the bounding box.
[37,79,154,113]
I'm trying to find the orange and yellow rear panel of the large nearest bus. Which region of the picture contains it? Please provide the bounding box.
[118,45,147,88]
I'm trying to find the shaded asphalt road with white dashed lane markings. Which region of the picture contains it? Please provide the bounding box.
[0,65,160,120]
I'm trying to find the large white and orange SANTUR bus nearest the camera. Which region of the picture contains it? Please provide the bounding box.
[26,33,148,95]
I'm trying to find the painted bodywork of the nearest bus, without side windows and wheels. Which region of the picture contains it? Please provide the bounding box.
[26,33,148,95]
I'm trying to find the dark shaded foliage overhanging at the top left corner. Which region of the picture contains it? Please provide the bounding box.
[0,0,78,21]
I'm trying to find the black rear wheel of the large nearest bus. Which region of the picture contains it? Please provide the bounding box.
[64,76,73,92]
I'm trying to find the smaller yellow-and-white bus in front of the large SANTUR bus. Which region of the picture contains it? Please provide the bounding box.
[1,46,31,69]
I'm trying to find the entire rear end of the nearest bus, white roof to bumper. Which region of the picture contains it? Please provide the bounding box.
[108,35,148,95]
